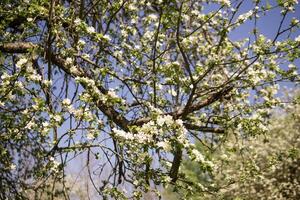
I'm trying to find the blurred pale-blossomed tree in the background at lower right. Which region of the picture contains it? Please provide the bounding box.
[165,91,300,199]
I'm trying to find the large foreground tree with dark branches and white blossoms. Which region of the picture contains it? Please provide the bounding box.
[0,0,300,199]
